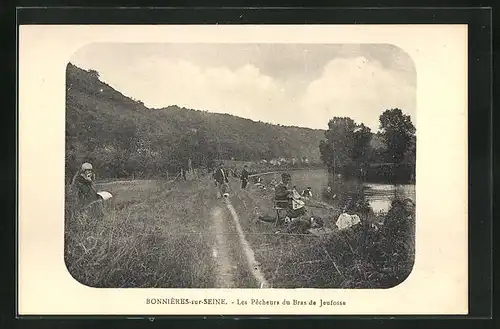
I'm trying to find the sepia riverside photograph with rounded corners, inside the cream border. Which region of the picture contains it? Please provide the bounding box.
[64,42,416,289]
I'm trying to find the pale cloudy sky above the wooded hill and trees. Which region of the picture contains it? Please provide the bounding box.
[71,43,416,131]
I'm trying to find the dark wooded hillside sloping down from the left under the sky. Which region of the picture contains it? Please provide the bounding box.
[66,64,324,178]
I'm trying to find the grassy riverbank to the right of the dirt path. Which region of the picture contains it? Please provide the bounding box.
[233,181,415,288]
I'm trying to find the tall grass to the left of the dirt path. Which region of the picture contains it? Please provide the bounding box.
[65,179,213,288]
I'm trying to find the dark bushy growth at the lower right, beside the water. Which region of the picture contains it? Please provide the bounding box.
[312,192,415,288]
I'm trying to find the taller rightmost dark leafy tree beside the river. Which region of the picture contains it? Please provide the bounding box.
[379,108,415,163]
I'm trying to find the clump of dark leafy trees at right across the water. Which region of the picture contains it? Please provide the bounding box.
[319,108,416,179]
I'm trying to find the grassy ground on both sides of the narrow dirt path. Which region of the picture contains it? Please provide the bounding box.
[65,172,413,288]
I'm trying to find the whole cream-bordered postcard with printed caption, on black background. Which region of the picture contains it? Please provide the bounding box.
[17,24,469,317]
